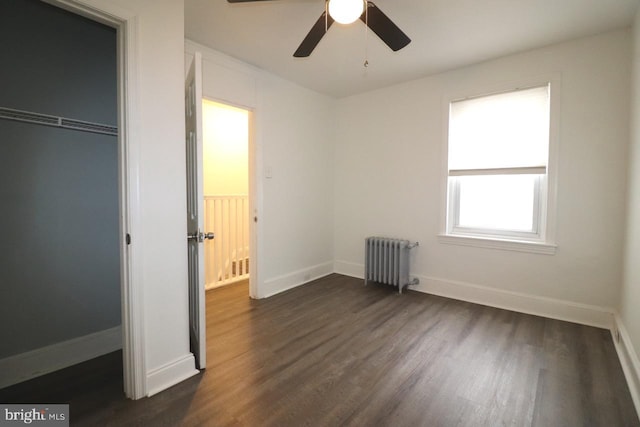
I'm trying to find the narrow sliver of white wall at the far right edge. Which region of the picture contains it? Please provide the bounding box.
[618,5,640,408]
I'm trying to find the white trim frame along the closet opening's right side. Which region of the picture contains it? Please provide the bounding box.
[43,0,147,399]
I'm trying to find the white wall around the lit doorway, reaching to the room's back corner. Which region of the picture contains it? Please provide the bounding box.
[186,41,336,298]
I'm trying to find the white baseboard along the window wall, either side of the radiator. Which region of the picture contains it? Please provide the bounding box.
[334,261,614,329]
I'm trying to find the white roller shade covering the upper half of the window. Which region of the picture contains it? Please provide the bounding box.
[448,85,549,176]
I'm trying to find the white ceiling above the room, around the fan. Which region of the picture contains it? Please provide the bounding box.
[185,0,639,98]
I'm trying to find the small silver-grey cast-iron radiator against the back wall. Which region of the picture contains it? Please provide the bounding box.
[364,237,420,293]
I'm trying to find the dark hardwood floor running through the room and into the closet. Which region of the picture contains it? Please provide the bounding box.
[0,274,640,427]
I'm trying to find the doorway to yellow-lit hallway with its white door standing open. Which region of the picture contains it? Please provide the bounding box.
[185,51,257,369]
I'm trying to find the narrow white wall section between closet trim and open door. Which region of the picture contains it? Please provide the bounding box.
[92,0,192,393]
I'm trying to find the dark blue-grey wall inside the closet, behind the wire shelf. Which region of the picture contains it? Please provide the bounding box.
[0,0,120,358]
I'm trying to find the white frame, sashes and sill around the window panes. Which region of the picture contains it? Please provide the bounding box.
[438,75,560,254]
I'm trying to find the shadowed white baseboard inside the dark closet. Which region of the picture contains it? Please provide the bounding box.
[0,326,122,388]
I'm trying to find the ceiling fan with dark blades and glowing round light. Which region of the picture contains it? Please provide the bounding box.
[227,0,411,58]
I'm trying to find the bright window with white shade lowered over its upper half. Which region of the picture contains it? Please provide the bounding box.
[446,84,550,251]
